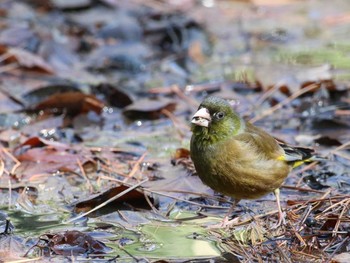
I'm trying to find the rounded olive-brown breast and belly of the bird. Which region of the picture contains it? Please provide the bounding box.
[191,137,290,199]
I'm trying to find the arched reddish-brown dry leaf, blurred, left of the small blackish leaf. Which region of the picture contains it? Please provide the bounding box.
[34,91,104,116]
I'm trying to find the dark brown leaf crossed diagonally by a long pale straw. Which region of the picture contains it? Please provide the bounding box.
[74,185,154,213]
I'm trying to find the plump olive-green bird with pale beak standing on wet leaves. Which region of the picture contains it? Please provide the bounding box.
[190,96,314,227]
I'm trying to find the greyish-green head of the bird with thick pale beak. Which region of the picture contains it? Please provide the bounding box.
[191,96,244,139]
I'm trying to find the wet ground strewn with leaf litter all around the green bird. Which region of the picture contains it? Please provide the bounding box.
[0,0,350,262]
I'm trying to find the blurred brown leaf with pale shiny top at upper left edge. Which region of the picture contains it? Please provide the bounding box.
[0,47,54,74]
